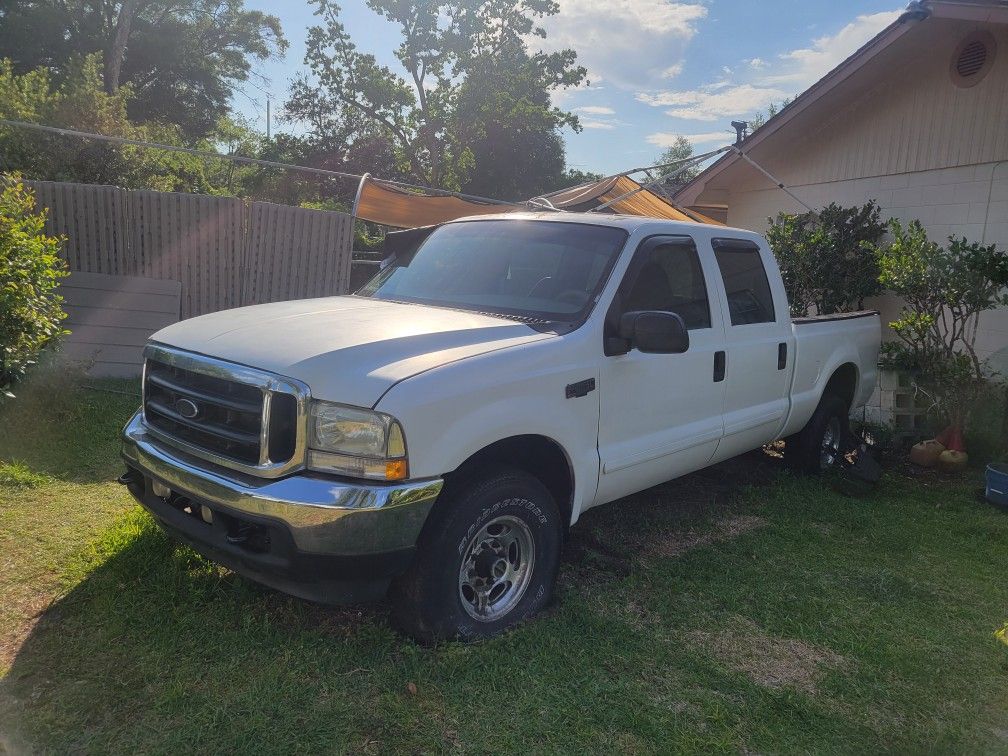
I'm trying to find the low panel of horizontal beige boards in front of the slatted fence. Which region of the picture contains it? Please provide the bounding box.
[59,272,181,377]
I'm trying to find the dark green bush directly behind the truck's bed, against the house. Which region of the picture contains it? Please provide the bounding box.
[766,202,886,316]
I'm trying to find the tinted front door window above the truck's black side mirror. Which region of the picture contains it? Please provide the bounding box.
[622,239,711,331]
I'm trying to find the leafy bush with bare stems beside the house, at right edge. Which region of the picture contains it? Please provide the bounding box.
[878,220,1008,427]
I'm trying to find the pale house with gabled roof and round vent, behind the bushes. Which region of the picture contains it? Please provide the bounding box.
[674,0,1008,373]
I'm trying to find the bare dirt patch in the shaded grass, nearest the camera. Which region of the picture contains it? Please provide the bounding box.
[688,617,845,696]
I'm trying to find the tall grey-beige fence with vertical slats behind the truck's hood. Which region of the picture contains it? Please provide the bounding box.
[28,181,353,318]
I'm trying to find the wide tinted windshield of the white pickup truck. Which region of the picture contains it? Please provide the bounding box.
[358,221,627,323]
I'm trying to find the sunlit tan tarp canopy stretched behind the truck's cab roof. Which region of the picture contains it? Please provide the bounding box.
[354,175,723,229]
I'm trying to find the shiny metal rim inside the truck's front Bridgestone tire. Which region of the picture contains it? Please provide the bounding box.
[459,515,535,622]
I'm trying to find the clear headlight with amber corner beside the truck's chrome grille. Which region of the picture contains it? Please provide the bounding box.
[308,399,409,481]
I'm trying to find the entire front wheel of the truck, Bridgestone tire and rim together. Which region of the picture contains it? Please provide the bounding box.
[389,470,562,642]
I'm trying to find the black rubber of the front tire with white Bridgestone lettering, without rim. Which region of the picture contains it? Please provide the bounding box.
[389,468,562,643]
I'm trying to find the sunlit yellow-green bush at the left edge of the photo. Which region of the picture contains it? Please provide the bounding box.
[0,174,67,396]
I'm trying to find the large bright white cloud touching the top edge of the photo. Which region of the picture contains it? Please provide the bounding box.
[529,0,707,89]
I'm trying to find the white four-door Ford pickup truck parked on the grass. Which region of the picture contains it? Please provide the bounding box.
[121,213,880,640]
